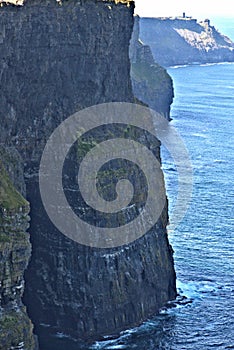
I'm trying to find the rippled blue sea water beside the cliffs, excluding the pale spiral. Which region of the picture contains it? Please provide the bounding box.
[37,63,234,350]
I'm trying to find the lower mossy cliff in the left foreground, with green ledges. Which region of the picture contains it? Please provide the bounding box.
[0,148,35,350]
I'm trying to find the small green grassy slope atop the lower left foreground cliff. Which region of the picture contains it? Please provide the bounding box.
[0,161,28,210]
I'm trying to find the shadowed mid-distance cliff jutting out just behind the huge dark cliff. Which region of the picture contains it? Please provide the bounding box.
[130,16,174,120]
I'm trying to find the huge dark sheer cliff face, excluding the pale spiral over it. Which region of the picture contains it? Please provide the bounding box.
[0,0,176,349]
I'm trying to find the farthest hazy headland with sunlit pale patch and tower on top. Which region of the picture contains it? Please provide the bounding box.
[140,17,234,67]
